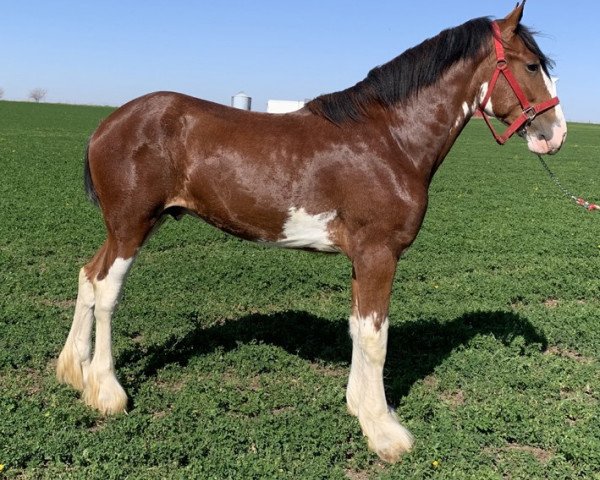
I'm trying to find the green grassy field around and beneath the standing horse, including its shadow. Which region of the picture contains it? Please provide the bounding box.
[0,102,600,480]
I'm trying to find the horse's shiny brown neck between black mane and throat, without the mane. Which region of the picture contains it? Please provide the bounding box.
[389,61,482,180]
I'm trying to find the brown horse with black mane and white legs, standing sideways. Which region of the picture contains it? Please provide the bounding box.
[56,2,567,462]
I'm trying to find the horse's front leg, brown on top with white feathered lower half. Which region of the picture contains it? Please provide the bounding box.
[346,246,413,463]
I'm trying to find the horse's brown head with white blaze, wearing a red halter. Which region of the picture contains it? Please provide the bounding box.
[481,1,567,154]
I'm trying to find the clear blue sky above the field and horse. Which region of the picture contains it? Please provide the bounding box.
[0,0,600,123]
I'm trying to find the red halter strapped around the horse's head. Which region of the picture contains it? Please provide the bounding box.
[479,22,559,145]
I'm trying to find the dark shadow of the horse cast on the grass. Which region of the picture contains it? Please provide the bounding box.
[118,311,547,403]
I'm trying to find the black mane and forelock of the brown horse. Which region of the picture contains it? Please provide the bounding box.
[306,17,552,125]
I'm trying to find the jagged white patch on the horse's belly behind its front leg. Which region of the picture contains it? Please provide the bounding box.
[265,207,339,252]
